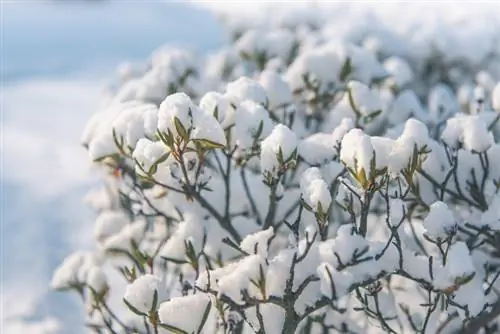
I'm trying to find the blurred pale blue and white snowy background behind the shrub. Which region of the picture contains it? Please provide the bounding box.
[0,0,500,334]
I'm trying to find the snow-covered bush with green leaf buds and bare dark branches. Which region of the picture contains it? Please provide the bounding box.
[52,10,500,334]
